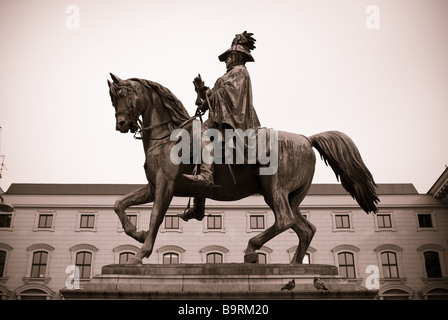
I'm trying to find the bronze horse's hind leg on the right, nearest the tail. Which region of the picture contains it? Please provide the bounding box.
[290,188,316,264]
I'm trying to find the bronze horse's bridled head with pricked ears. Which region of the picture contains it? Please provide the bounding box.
[107,73,143,133]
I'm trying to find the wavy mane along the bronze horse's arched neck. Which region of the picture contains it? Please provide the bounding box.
[129,78,190,126]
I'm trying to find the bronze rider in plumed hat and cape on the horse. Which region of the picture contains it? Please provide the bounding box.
[181,31,260,221]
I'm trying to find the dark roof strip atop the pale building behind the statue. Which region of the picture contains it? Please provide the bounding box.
[5,183,418,195]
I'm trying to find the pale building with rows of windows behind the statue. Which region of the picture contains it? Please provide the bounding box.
[0,172,448,299]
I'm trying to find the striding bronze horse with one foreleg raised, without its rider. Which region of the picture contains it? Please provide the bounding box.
[108,74,379,264]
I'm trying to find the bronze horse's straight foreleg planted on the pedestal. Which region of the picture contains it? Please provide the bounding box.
[128,179,174,264]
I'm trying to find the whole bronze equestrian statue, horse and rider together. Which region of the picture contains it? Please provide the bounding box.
[108,32,379,264]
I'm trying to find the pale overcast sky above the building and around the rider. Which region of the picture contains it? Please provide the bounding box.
[0,0,448,193]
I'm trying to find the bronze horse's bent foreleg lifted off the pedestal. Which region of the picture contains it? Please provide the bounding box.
[114,184,154,243]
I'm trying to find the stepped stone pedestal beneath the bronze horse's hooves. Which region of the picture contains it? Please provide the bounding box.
[61,263,377,300]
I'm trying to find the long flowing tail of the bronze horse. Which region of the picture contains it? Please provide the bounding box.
[309,131,379,213]
